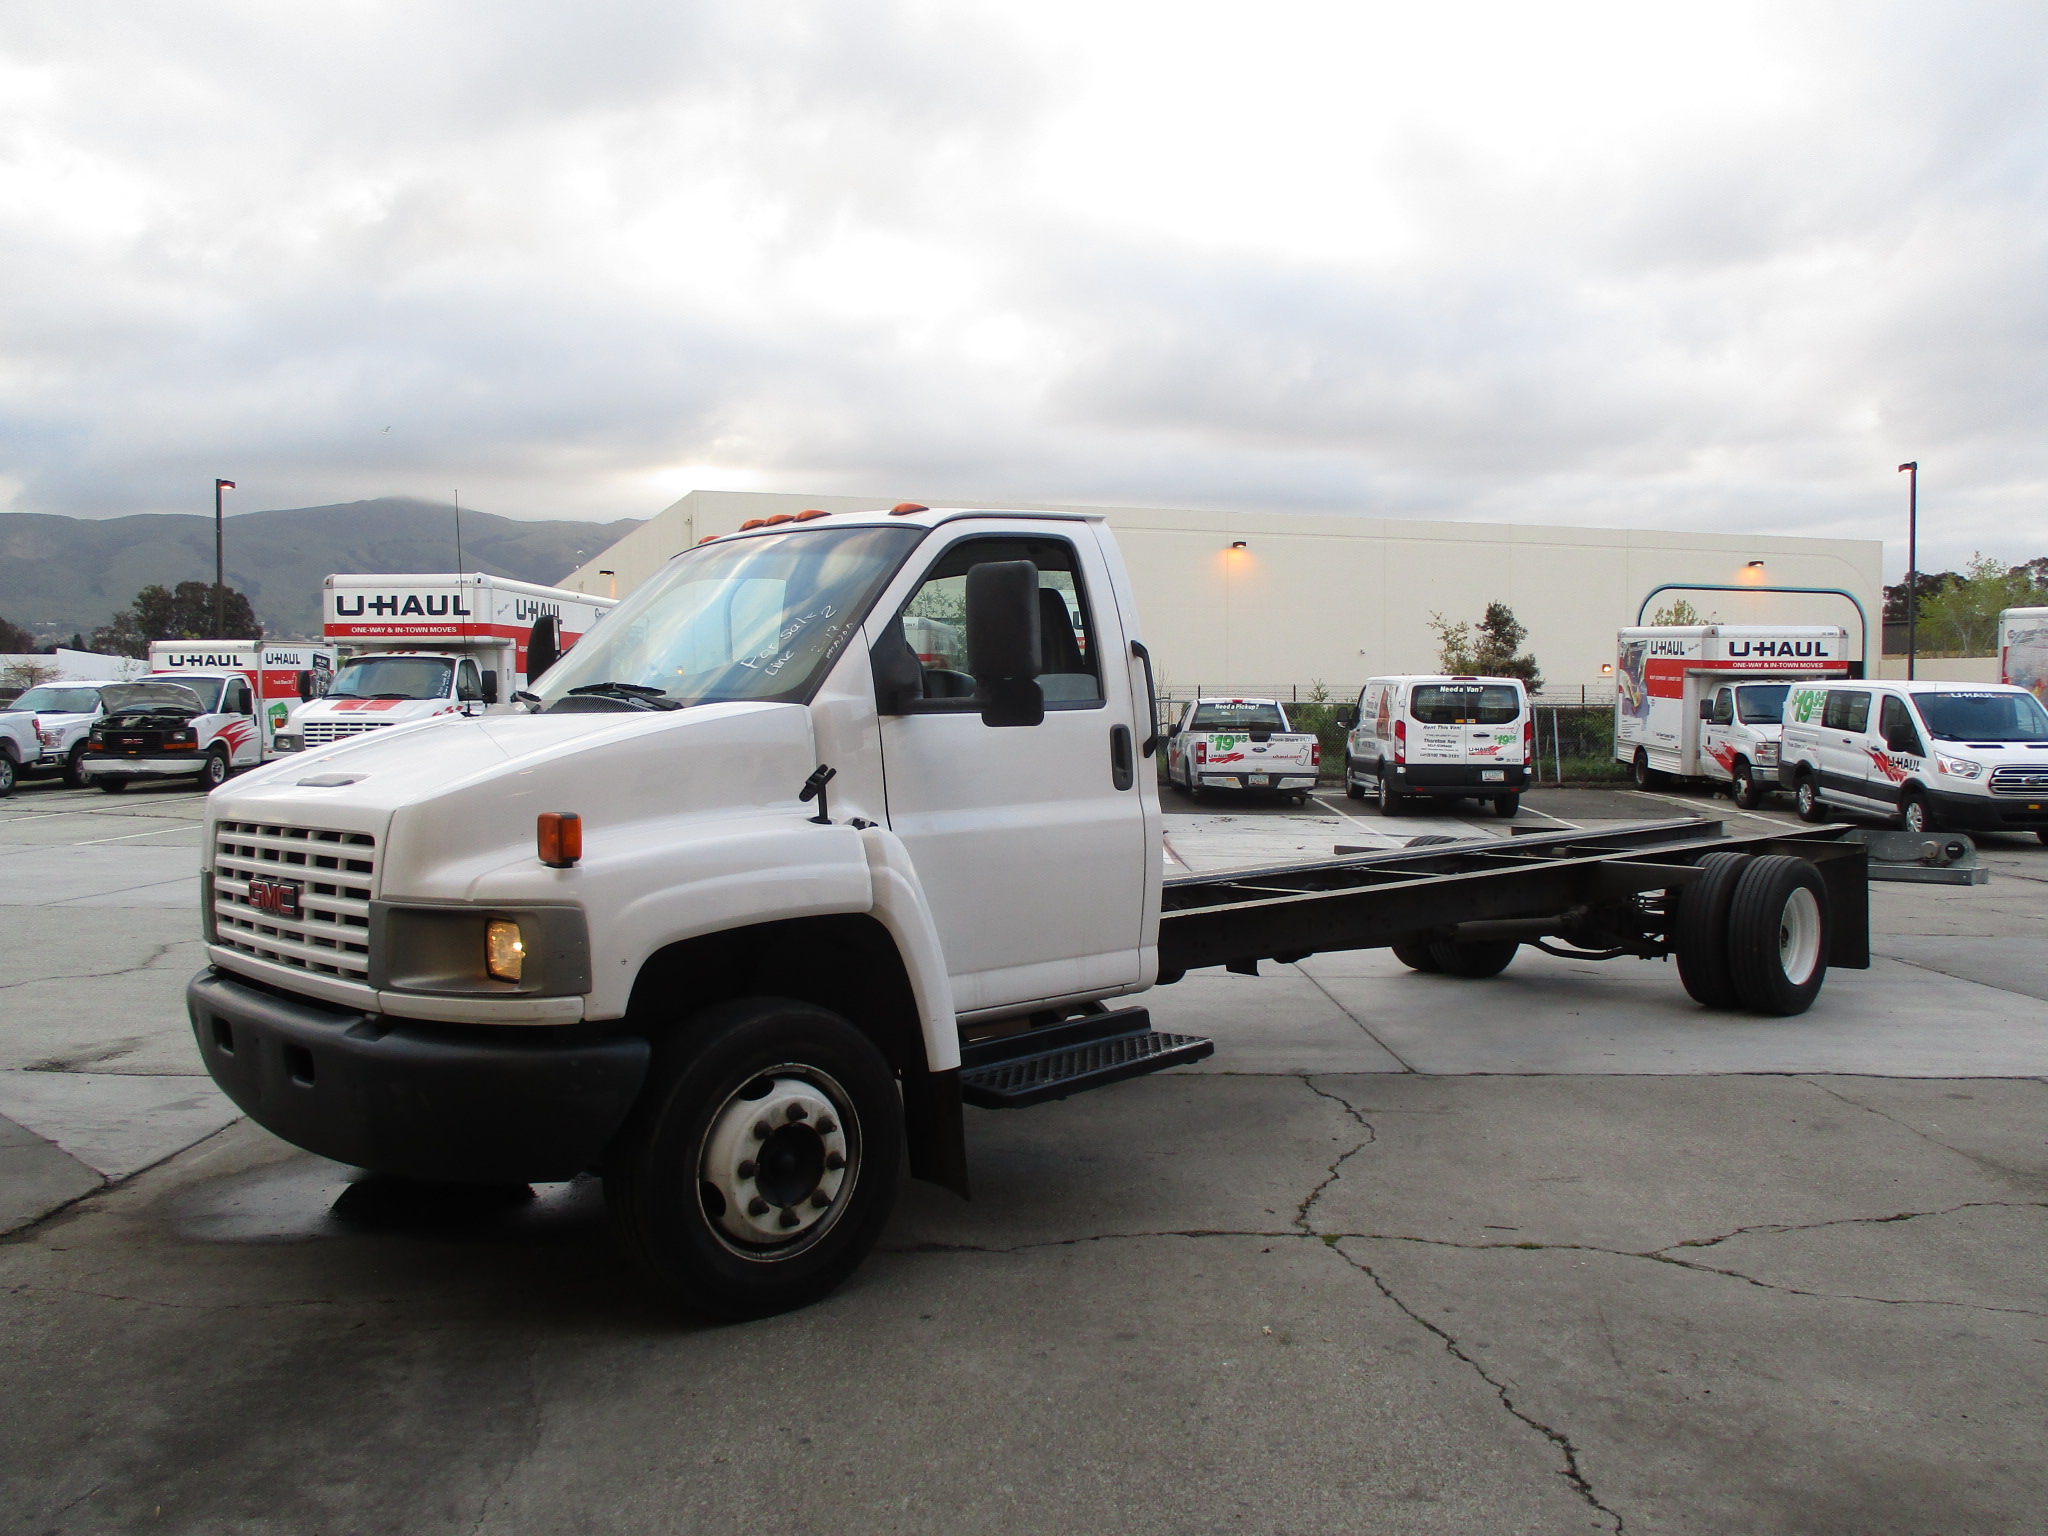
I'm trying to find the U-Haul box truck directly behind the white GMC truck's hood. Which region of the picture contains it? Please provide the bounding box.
[283,571,612,752]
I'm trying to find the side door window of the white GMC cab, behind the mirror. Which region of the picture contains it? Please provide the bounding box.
[883,535,1104,711]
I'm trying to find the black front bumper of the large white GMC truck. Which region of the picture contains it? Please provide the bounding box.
[184,971,649,1184]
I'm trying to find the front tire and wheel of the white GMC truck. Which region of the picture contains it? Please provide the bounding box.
[604,997,903,1321]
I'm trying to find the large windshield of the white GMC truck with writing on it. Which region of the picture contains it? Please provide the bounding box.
[535,526,924,709]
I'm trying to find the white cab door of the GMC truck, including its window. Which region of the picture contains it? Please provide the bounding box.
[868,524,1161,1014]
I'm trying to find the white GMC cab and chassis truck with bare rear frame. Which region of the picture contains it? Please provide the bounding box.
[188,506,1868,1317]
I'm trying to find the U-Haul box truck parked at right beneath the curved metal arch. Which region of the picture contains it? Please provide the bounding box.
[1614,625,1860,805]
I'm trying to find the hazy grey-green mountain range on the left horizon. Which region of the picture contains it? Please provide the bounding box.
[0,496,639,643]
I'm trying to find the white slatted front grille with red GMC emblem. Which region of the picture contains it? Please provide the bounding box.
[213,821,377,981]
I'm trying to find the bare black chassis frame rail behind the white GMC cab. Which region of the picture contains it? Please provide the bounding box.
[1159,817,1870,985]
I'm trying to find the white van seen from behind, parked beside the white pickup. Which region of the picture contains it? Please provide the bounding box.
[1343,674,1536,815]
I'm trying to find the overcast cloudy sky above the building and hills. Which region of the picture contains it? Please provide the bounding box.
[0,0,2048,567]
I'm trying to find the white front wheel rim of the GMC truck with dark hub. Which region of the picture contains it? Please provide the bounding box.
[696,1063,860,1260]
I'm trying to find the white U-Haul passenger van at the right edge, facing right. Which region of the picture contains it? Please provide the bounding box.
[1778,682,2048,844]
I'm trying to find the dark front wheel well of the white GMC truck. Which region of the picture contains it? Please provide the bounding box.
[629,913,928,1075]
